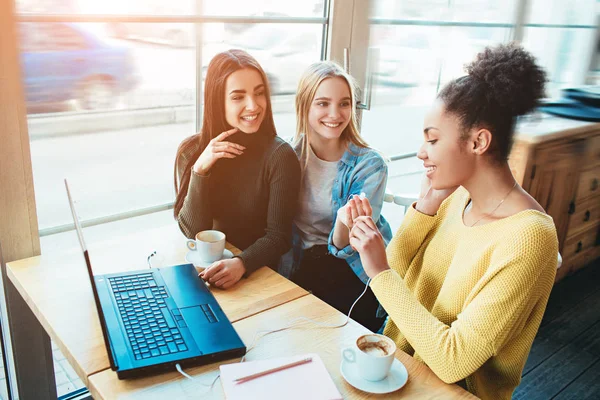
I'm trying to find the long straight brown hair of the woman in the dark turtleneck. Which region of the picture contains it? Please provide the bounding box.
[173,49,277,218]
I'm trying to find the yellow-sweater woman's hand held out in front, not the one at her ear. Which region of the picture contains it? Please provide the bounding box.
[350,216,390,278]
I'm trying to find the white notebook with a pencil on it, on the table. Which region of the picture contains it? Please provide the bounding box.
[220,354,342,400]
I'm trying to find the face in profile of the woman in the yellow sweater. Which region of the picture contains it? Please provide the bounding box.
[417,100,475,189]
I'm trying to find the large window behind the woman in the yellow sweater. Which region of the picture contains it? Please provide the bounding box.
[353,0,599,219]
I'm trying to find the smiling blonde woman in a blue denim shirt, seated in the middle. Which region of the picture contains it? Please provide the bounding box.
[283,62,392,331]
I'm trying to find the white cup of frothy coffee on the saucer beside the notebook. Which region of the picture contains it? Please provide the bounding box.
[342,333,396,382]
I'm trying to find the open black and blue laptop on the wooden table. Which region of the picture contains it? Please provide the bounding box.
[65,179,246,379]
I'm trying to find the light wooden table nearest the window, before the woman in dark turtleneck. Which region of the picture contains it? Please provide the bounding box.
[1,225,308,391]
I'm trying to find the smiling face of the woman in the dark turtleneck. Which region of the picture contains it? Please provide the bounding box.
[225,68,267,133]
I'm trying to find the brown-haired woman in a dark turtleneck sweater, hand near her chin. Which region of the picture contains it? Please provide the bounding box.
[174,50,300,289]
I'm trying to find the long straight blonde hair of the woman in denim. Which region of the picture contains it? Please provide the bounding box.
[294,61,369,168]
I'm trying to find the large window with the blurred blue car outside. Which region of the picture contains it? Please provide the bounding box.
[17,0,328,235]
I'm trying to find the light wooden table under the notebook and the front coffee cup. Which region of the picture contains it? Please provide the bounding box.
[89,295,475,400]
